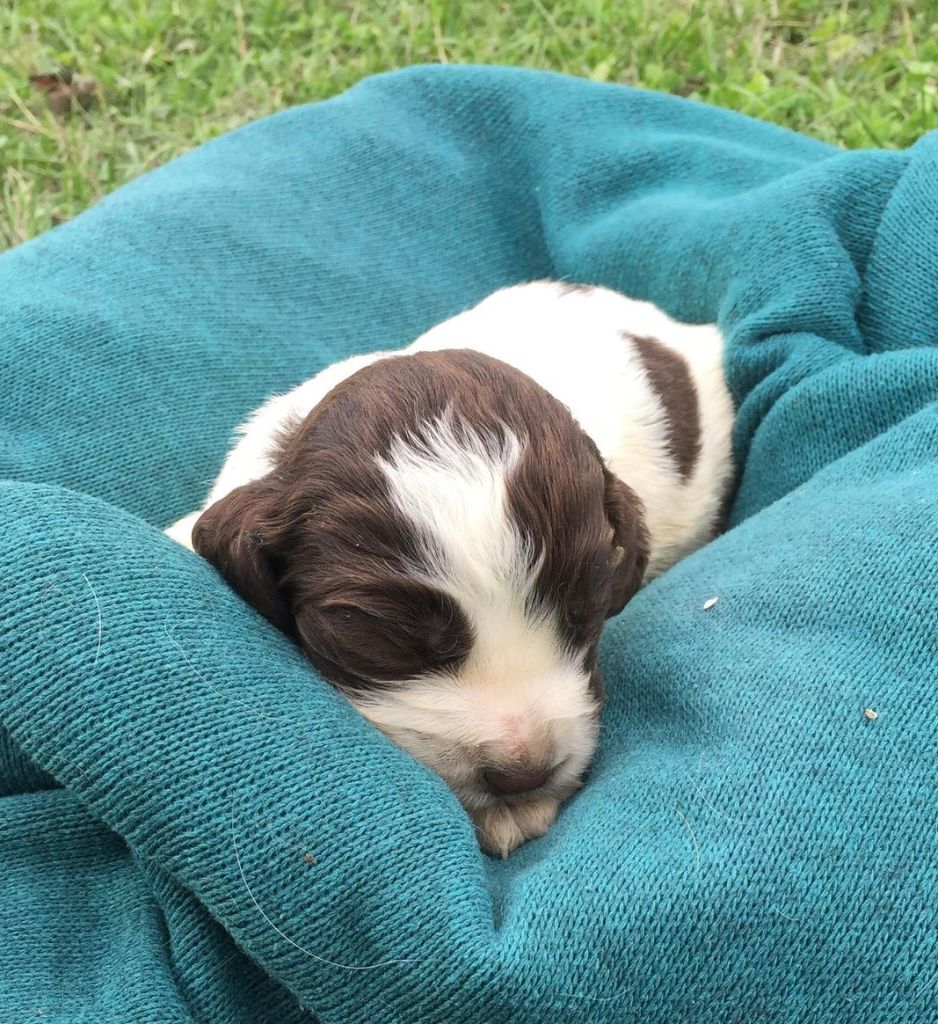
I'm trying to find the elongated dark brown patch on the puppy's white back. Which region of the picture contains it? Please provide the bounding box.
[624,334,700,480]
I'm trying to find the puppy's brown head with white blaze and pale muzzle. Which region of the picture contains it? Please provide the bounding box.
[194,350,647,823]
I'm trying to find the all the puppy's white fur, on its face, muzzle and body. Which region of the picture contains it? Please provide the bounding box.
[167,282,733,854]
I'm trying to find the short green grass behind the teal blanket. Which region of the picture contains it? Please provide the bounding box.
[0,0,938,248]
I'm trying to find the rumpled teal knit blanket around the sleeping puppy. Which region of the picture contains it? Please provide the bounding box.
[0,68,938,1024]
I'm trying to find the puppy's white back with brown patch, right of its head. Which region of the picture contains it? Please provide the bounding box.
[408,281,733,577]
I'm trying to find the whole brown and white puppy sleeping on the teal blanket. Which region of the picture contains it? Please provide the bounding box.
[167,282,733,856]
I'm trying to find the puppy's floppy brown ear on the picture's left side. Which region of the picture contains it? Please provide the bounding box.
[193,479,294,636]
